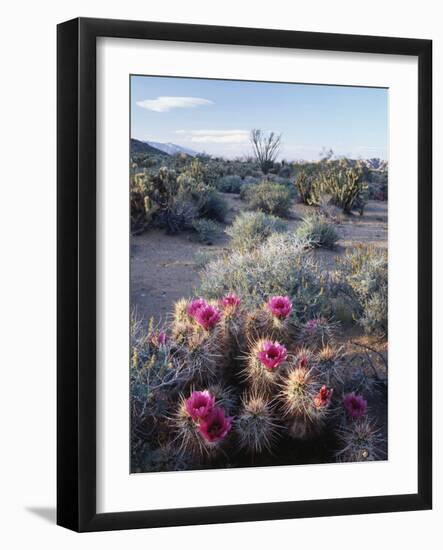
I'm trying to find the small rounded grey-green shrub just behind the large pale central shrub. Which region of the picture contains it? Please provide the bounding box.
[225,212,288,252]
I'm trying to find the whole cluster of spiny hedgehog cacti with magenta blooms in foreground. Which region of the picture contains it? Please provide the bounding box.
[131,293,386,468]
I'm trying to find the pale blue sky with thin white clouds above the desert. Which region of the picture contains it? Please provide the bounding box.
[131,76,388,160]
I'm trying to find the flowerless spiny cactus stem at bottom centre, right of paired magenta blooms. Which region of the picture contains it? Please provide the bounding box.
[235,394,280,454]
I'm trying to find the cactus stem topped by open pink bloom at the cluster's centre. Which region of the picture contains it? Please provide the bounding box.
[243,338,288,393]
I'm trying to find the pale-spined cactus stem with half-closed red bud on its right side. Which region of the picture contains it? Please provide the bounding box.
[279,366,332,439]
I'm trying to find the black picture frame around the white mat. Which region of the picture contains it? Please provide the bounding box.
[57,18,432,531]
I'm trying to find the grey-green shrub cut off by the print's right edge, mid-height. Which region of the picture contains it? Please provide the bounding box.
[338,245,388,334]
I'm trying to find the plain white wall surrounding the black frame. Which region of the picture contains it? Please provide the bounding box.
[0,0,443,550]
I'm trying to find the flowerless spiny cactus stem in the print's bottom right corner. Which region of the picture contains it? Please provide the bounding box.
[335,418,386,462]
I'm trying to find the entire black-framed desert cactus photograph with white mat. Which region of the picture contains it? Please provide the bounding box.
[57,18,432,531]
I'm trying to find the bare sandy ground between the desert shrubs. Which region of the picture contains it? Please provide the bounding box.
[131,193,388,322]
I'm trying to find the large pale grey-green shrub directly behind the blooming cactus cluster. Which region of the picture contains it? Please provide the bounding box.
[200,233,329,319]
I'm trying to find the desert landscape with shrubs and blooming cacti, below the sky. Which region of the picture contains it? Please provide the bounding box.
[131,140,388,472]
